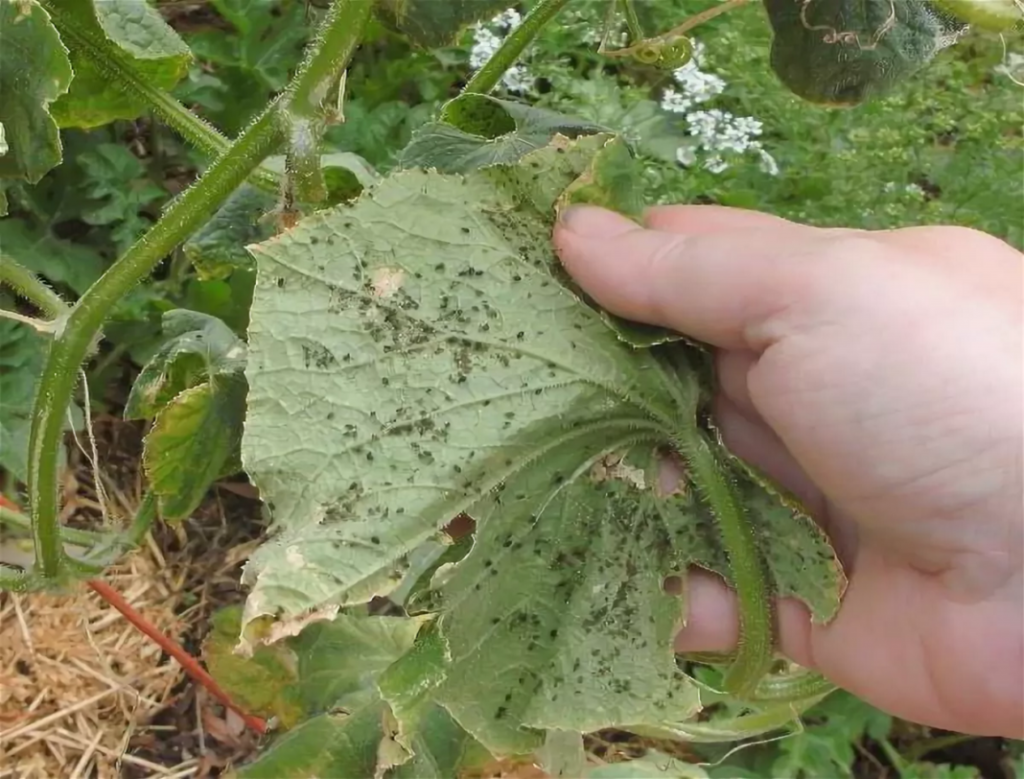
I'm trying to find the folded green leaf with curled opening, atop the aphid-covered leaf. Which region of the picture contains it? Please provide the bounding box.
[399,94,605,173]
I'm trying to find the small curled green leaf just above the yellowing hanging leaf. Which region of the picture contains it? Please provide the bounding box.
[124,308,246,420]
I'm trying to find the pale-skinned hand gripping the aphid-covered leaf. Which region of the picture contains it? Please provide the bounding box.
[554,206,1024,738]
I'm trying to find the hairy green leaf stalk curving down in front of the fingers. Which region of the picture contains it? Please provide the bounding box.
[680,429,775,697]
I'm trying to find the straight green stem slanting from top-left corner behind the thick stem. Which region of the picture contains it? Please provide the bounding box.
[43,0,281,193]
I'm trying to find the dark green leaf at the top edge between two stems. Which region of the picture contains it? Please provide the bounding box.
[377,0,513,47]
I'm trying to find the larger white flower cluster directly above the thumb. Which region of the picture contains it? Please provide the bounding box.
[662,41,778,176]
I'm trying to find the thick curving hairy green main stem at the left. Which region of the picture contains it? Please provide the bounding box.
[28,0,371,579]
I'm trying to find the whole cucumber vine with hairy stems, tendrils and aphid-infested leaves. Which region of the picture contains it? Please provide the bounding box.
[0,0,1007,777]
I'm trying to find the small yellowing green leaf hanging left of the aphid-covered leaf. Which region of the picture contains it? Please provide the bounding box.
[142,376,246,520]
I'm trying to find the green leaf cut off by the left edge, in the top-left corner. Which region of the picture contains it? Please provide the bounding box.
[0,0,72,183]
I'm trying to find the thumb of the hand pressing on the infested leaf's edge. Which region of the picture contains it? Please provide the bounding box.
[554,206,825,351]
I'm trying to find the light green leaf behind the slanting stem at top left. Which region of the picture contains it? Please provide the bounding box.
[46,0,191,127]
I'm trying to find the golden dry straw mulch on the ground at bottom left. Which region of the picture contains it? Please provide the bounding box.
[0,546,195,779]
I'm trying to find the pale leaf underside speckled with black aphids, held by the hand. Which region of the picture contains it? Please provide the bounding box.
[243,135,843,753]
